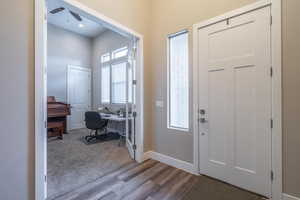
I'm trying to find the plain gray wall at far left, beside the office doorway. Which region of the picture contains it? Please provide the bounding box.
[0,0,34,200]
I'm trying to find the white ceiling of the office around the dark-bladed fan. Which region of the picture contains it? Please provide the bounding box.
[47,0,107,37]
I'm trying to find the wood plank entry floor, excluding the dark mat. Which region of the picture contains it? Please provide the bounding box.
[50,160,197,200]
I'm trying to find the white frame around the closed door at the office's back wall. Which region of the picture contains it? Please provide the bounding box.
[67,64,92,131]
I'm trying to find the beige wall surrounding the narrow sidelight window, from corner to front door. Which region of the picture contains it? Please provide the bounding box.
[151,0,255,162]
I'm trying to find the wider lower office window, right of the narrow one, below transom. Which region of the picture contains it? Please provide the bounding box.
[111,62,127,104]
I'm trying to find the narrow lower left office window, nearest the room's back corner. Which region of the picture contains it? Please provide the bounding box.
[101,65,110,104]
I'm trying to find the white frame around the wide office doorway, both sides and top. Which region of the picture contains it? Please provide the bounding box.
[34,0,144,200]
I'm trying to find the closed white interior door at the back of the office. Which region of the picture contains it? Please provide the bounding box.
[68,65,91,130]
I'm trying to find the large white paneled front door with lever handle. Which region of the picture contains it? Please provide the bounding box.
[198,7,271,197]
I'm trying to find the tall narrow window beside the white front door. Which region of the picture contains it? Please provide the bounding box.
[168,31,189,130]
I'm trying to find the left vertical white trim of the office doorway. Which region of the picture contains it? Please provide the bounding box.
[34,0,47,200]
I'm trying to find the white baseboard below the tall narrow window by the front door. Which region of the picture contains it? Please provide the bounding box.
[144,151,199,175]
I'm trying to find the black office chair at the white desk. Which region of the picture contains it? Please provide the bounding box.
[85,111,108,142]
